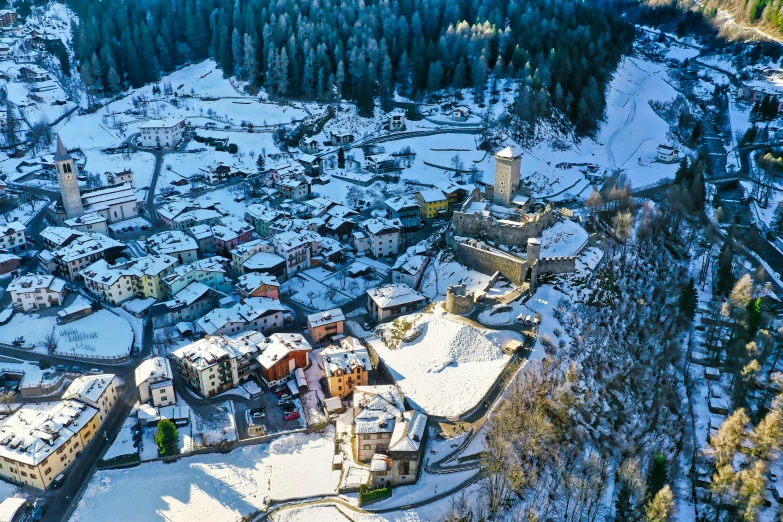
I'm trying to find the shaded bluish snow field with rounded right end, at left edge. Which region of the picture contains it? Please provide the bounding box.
[0,300,133,357]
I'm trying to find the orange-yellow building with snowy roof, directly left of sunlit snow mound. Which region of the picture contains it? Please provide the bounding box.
[321,337,372,399]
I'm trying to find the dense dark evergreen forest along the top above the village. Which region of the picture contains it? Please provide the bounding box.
[70,0,634,132]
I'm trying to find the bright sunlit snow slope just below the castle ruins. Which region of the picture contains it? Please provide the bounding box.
[368,307,521,416]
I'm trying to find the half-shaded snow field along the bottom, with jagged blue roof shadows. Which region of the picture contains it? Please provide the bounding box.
[71,427,340,522]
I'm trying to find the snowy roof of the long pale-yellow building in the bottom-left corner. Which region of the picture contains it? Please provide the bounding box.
[0,400,98,466]
